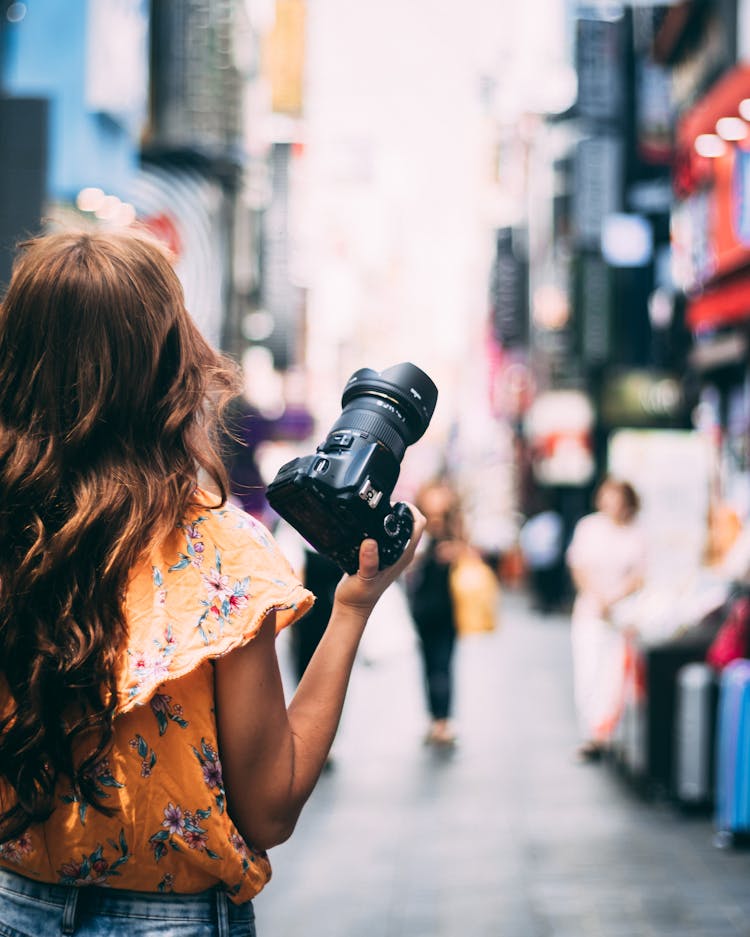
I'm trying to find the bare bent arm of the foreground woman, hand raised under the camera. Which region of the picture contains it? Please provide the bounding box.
[216,509,424,849]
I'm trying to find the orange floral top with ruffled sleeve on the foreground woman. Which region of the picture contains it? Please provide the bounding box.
[0,492,313,904]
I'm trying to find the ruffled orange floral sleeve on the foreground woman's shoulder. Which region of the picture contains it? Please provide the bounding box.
[118,505,314,713]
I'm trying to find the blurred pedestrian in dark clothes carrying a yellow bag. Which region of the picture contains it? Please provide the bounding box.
[407,480,467,746]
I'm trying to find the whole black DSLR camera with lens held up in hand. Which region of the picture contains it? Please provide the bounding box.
[266,362,437,573]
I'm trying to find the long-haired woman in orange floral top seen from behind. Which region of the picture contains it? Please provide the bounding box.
[0,234,422,937]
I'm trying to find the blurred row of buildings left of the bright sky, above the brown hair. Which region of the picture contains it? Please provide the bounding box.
[0,0,312,410]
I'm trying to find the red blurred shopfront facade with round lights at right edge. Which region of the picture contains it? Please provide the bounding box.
[654,0,750,502]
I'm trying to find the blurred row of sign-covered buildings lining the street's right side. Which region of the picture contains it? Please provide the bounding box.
[488,0,750,556]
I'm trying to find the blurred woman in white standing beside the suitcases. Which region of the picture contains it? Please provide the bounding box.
[567,478,646,761]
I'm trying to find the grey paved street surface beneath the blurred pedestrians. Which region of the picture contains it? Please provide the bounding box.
[255,591,750,937]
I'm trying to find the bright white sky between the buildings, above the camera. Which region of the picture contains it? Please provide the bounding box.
[303,0,564,424]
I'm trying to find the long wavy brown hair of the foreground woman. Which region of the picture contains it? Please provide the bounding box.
[0,233,237,842]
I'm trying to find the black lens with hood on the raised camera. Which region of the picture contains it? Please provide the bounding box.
[329,362,438,462]
